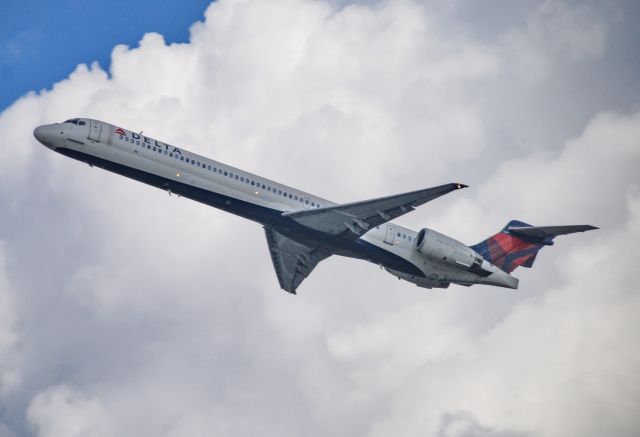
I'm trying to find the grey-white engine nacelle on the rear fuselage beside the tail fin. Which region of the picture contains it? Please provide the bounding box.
[414,228,483,276]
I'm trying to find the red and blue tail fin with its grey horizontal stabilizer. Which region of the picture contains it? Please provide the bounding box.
[470,220,598,273]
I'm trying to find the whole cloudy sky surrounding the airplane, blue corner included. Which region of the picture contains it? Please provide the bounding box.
[0,0,640,437]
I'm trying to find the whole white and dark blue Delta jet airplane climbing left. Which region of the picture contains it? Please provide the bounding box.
[34,118,598,294]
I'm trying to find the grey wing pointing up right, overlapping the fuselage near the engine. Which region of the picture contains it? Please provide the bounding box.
[282,184,467,239]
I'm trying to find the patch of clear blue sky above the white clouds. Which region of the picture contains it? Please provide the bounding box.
[0,0,209,109]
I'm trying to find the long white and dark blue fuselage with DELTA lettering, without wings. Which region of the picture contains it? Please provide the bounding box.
[35,118,517,288]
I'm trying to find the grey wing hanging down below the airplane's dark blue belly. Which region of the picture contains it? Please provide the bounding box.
[264,227,331,294]
